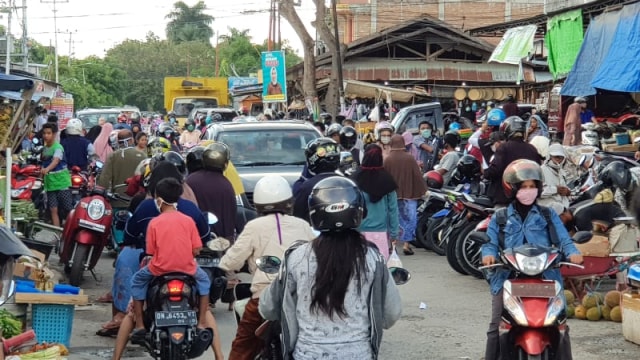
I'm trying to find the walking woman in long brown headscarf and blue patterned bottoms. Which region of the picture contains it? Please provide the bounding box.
[383,134,427,255]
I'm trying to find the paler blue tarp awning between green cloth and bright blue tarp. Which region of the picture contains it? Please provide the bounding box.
[560,10,629,96]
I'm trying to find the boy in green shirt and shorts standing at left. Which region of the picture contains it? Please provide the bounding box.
[41,122,72,226]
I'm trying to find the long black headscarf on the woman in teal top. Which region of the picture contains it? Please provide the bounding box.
[351,144,398,203]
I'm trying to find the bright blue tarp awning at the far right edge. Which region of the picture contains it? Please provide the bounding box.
[591,3,640,92]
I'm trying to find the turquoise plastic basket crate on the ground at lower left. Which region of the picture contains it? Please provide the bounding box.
[31,304,75,348]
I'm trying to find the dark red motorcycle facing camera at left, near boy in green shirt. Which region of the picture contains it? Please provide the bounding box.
[60,187,128,286]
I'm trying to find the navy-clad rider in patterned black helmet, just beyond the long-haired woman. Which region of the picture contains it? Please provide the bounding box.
[293,138,340,221]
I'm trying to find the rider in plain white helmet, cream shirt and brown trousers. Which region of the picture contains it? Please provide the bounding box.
[220,175,315,360]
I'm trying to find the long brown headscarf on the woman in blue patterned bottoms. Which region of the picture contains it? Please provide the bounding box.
[384,134,427,200]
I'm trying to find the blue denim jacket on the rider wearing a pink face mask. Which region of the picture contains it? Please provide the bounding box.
[482,204,580,295]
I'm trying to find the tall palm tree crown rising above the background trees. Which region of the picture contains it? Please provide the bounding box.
[165,1,214,44]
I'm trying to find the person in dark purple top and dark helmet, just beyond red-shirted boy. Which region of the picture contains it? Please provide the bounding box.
[186,142,236,240]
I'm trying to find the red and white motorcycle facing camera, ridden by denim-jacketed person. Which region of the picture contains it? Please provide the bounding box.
[469,231,591,359]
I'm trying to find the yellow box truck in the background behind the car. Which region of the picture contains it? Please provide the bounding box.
[164,77,229,125]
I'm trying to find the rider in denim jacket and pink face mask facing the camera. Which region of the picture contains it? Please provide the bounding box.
[482,160,582,360]
